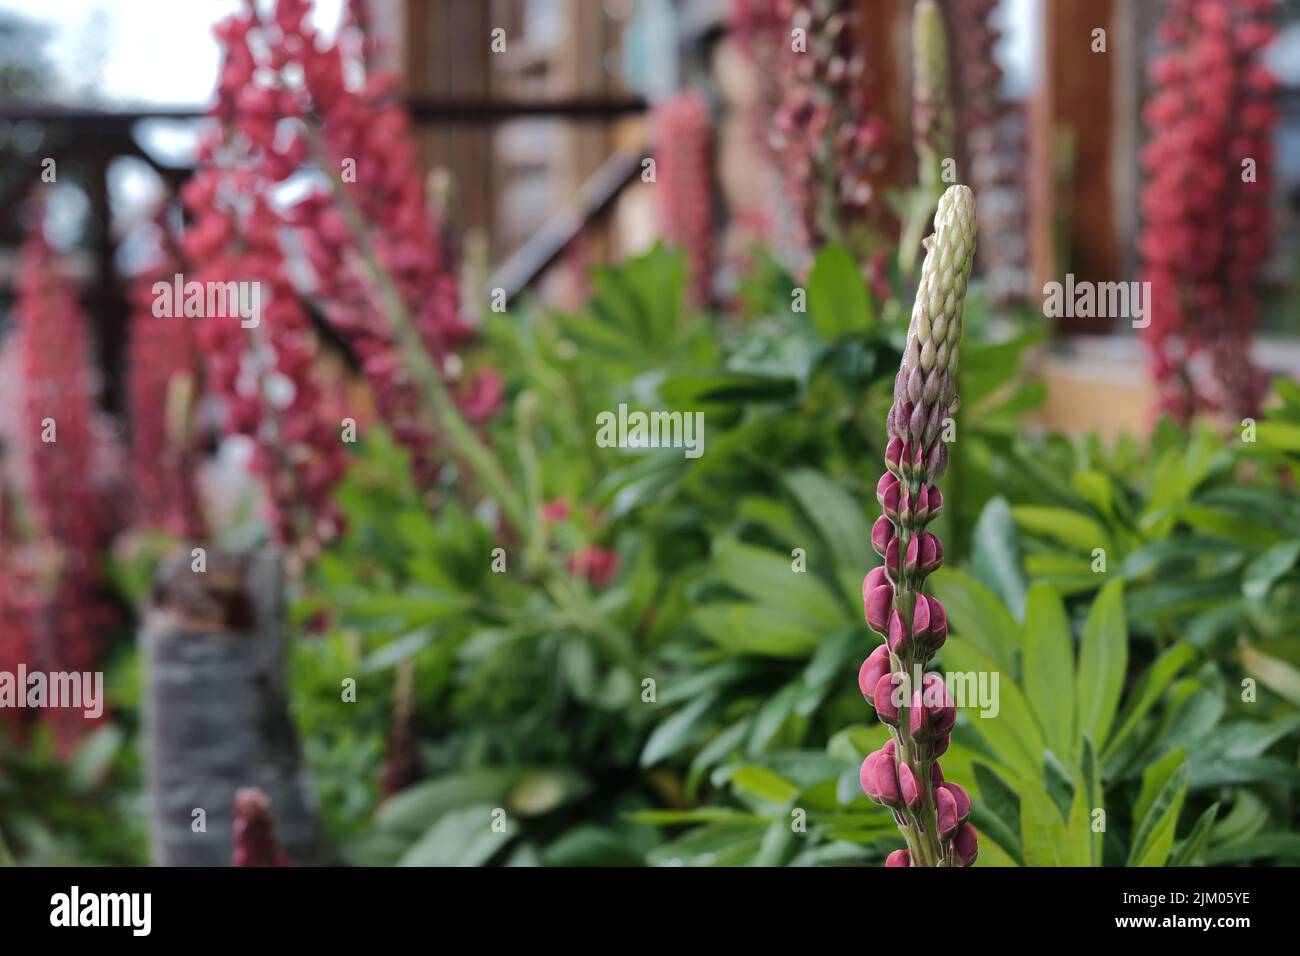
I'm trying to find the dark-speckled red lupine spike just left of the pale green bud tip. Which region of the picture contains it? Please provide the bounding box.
[775,0,885,248]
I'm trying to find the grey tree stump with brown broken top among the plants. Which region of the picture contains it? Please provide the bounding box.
[140,549,324,866]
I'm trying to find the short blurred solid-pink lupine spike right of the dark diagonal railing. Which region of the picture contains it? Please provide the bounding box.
[651,91,714,306]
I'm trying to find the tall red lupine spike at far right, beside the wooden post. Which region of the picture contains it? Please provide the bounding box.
[1140,0,1278,419]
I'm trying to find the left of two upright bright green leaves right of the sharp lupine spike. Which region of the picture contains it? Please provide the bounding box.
[1023,584,1076,760]
